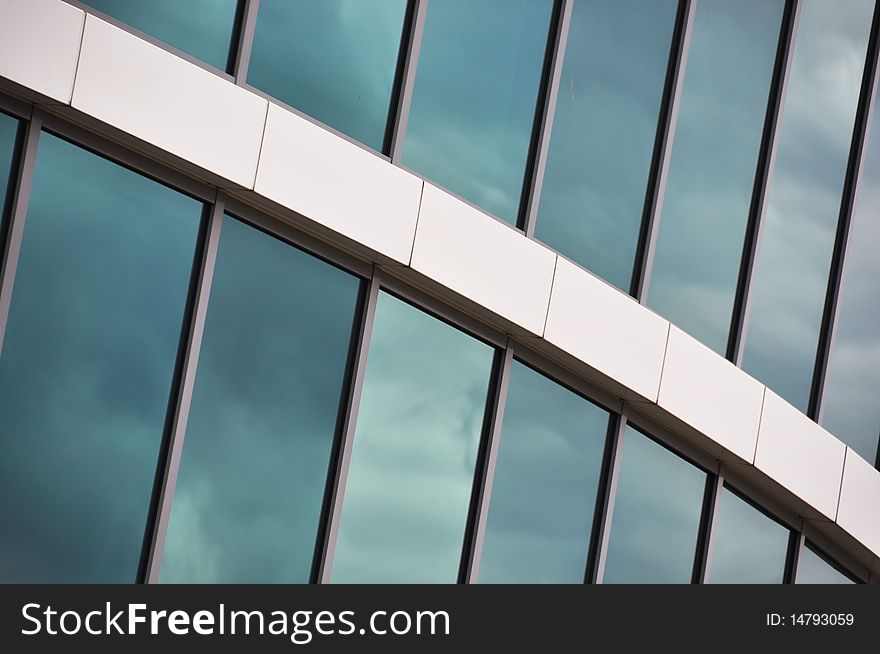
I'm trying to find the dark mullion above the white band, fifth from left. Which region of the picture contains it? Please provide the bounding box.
[726,0,801,366]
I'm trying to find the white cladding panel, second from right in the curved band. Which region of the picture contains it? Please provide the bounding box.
[755,389,846,520]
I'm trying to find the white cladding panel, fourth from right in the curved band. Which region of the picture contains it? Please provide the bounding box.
[544,257,669,402]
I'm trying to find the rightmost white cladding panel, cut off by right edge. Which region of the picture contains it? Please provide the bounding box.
[837,448,880,556]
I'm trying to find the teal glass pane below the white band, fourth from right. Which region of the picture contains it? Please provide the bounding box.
[480,361,608,584]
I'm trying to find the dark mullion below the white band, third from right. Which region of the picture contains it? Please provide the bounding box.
[584,408,626,584]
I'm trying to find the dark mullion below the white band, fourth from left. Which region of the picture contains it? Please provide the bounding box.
[459,342,513,584]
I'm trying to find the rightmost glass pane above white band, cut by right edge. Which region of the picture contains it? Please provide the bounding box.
[822,77,880,464]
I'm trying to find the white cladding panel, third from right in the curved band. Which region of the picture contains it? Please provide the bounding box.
[657,325,764,463]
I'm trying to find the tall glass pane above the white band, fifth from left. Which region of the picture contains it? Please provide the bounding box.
[648,0,785,354]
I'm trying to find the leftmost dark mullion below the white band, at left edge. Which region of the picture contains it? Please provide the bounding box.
[0,109,43,362]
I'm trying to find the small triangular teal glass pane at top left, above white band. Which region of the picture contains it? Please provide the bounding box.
[82,0,238,71]
